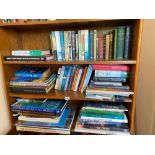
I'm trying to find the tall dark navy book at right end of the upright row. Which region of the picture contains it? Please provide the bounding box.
[124,26,131,59]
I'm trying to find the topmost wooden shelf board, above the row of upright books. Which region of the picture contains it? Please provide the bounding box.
[0,19,135,29]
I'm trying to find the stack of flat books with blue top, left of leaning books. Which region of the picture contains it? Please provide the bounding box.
[10,67,56,94]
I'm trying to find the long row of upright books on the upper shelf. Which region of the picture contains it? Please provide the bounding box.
[50,26,132,61]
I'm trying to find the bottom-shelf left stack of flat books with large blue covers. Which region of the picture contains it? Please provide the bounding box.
[11,99,75,134]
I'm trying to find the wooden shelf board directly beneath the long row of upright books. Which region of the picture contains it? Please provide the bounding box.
[3,60,136,65]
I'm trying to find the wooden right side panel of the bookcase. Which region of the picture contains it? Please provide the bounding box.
[129,20,143,134]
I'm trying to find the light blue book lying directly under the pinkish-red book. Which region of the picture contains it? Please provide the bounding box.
[95,70,127,78]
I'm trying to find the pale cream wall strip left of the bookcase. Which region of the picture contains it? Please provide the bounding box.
[0,59,10,135]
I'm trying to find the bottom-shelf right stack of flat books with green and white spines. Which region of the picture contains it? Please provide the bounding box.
[75,101,130,135]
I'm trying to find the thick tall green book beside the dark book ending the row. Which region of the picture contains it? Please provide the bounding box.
[116,26,125,60]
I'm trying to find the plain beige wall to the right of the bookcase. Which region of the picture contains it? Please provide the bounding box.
[136,20,155,134]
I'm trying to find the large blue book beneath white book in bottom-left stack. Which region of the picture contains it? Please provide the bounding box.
[16,108,71,128]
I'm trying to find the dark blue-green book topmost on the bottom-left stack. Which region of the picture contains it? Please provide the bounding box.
[11,99,67,115]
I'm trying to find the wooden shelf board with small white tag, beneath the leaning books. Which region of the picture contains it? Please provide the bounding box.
[9,90,132,102]
